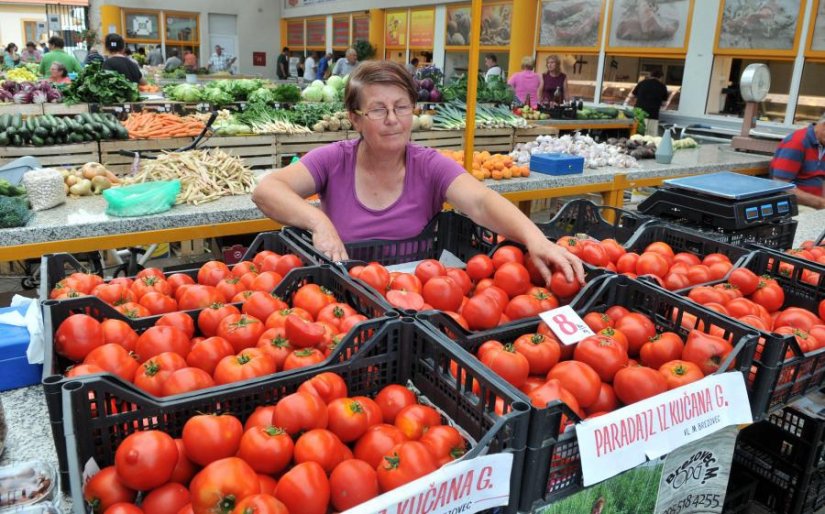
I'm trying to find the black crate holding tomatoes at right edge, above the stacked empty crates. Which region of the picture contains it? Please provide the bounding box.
[677,248,825,412]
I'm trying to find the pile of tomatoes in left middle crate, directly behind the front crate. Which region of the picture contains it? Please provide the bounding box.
[54,280,374,396]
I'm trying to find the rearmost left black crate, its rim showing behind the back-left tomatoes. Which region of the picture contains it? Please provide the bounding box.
[39,232,323,300]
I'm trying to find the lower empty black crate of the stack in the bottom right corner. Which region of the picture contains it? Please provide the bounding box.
[733,437,825,514]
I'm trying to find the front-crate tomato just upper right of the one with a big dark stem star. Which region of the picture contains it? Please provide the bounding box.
[238,421,295,475]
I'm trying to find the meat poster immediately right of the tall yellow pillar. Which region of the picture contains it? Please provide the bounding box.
[539,0,602,47]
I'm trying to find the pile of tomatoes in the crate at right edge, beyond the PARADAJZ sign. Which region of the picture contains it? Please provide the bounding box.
[688,263,825,358]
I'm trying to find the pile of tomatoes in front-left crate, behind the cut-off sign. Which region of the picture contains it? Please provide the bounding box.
[83,373,467,514]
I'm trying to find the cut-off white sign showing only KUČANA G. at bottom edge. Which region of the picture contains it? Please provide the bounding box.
[343,453,513,514]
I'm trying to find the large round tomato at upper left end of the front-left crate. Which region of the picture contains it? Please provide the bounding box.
[115,430,178,491]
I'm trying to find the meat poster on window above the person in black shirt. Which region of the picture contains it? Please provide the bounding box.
[609,0,691,48]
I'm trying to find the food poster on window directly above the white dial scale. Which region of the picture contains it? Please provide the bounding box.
[718,0,802,50]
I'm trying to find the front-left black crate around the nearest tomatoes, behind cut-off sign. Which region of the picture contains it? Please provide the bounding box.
[62,318,528,513]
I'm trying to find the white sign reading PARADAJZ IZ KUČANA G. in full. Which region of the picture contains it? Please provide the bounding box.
[576,372,753,486]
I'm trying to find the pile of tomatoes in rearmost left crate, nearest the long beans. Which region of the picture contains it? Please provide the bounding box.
[49,250,304,318]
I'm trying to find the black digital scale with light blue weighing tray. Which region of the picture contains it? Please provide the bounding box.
[639,171,799,230]
